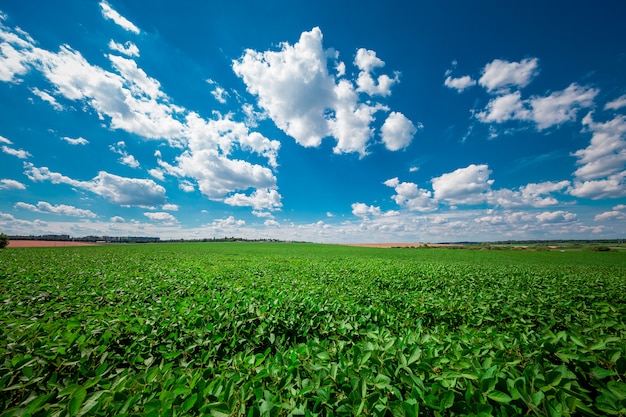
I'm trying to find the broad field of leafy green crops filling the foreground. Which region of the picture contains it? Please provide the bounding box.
[0,243,626,416]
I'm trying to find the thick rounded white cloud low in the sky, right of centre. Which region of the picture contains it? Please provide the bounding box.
[431,164,493,204]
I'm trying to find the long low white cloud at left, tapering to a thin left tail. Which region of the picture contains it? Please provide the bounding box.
[24,163,165,207]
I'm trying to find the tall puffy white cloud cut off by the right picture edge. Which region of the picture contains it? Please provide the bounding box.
[573,113,626,180]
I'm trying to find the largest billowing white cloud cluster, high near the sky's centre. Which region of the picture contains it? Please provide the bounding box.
[233,27,416,156]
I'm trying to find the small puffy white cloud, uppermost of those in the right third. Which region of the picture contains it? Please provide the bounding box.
[478,58,539,92]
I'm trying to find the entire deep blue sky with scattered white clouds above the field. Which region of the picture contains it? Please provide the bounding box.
[0,0,626,243]
